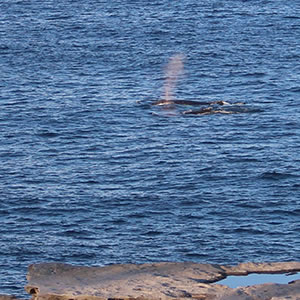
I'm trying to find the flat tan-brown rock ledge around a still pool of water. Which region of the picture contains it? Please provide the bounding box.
[24,262,300,300]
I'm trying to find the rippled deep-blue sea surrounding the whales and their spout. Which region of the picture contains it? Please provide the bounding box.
[0,0,300,297]
